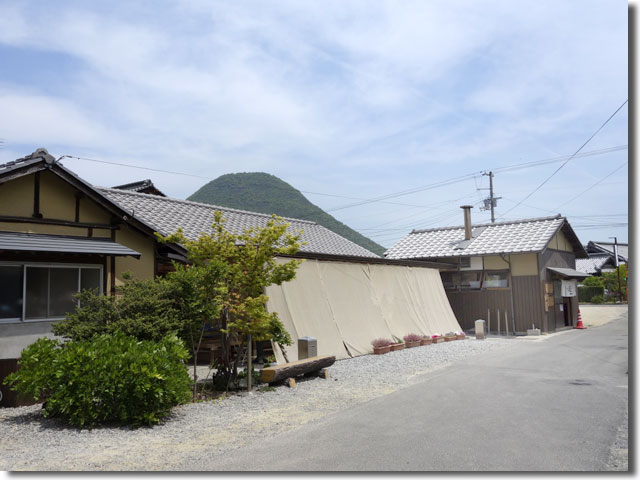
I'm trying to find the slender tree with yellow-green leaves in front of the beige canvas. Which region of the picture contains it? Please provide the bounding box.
[160,212,301,388]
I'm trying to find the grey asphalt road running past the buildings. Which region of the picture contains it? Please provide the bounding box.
[209,315,628,471]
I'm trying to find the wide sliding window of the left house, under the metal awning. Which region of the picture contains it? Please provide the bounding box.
[0,264,102,321]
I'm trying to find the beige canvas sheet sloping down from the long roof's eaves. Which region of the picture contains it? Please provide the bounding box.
[266,260,461,363]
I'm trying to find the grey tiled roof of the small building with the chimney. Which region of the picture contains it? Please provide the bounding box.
[385,216,566,259]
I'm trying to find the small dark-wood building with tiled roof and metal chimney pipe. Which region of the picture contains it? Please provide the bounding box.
[385,207,589,334]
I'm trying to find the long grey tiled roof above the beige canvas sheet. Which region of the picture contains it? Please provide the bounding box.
[96,188,379,258]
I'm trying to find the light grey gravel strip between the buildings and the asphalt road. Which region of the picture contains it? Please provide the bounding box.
[0,338,519,471]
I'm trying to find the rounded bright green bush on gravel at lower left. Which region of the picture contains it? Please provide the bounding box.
[4,332,191,427]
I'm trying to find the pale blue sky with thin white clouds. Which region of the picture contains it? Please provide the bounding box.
[0,0,629,247]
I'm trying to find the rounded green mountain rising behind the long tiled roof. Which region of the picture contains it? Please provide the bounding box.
[187,172,385,256]
